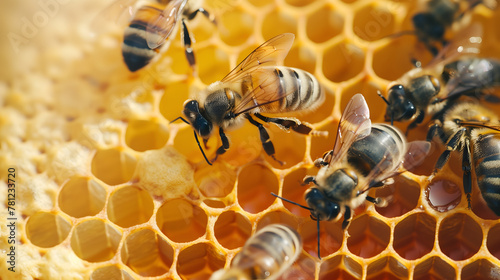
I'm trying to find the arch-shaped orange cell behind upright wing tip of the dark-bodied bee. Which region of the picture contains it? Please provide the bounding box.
[340,78,387,123]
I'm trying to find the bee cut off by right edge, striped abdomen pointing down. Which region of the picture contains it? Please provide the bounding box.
[427,101,500,216]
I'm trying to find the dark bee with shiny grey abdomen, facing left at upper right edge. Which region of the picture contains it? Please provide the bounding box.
[379,26,500,133]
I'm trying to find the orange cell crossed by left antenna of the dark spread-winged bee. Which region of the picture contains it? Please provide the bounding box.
[282,168,311,217]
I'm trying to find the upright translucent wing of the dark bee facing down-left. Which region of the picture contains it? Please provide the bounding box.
[329,93,371,164]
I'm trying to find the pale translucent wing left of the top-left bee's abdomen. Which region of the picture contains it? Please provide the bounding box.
[90,0,137,34]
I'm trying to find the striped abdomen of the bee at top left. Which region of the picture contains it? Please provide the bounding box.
[122,5,166,72]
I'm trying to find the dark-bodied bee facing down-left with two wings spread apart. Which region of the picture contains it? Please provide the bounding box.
[273,94,430,258]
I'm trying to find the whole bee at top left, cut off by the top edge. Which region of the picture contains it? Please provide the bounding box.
[94,0,215,72]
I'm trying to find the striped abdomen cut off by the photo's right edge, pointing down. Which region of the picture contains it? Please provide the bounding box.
[473,133,500,216]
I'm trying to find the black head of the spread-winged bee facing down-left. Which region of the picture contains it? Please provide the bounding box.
[305,187,340,221]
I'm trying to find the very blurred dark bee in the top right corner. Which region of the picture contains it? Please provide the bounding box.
[400,0,496,56]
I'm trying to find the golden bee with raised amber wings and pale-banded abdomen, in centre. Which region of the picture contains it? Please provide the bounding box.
[174,33,325,165]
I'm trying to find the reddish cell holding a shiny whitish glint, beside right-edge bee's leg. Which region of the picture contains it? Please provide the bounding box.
[425,180,462,212]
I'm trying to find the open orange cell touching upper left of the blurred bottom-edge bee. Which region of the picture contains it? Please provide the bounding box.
[214,211,252,250]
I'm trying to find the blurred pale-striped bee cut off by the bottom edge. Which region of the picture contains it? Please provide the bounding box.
[210,224,302,280]
